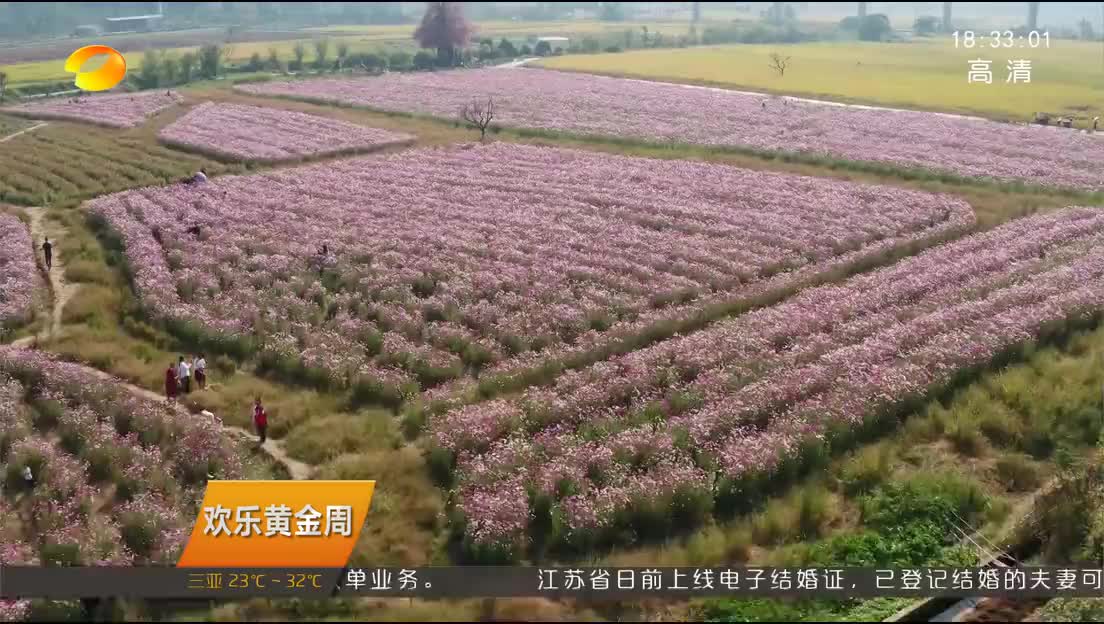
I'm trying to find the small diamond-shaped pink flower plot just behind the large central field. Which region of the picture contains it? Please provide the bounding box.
[158,102,414,162]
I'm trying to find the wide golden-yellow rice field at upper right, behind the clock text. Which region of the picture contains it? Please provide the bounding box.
[541,38,1104,126]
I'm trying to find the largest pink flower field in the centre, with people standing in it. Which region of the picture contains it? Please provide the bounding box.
[87,144,974,397]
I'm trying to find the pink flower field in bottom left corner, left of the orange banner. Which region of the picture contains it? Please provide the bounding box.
[0,347,242,574]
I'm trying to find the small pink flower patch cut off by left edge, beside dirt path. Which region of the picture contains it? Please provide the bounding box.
[0,213,39,327]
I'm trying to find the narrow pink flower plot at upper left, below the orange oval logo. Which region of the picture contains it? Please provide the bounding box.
[0,89,183,128]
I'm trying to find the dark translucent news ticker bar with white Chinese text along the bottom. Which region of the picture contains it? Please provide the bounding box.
[0,567,1104,600]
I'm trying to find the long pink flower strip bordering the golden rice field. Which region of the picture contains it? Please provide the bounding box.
[237,68,1104,189]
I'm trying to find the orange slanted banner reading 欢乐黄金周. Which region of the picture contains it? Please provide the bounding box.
[177,480,375,568]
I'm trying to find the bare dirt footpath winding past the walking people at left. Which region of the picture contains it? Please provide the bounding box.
[11,206,315,480]
